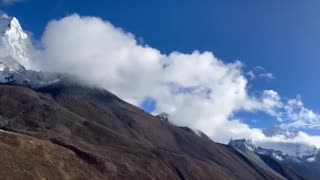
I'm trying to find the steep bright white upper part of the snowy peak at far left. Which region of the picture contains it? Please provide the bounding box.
[0,11,31,69]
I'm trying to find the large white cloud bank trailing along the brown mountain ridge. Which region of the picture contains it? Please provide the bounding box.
[33,14,320,147]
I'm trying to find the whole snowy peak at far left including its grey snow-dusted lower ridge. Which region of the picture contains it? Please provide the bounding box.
[0,10,67,88]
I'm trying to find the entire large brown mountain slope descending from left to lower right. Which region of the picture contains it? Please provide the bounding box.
[0,83,282,180]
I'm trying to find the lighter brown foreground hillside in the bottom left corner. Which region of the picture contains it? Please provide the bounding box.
[0,130,104,180]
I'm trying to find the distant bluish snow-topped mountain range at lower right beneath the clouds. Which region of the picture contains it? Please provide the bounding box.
[229,139,320,180]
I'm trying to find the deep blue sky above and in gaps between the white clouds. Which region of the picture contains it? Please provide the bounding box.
[2,0,320,143]
